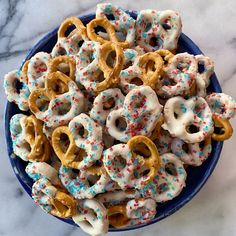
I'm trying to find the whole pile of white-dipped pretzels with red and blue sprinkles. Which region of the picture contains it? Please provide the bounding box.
[4,3,236,235]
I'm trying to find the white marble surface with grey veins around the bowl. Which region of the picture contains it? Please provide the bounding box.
[0,0,236,236]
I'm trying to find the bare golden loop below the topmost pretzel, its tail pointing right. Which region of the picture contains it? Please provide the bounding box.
[87,18,130,48]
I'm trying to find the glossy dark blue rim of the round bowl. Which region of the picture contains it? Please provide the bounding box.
[4,10,223,232]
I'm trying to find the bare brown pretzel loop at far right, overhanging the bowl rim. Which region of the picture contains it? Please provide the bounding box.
[212,115,233,141]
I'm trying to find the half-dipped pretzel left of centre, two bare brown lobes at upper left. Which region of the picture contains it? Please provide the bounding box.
[29,71,85,127]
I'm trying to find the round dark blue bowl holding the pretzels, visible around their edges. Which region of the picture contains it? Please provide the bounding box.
[5,11,223,231]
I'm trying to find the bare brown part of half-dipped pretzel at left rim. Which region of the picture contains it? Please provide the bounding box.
[20,115,50,162]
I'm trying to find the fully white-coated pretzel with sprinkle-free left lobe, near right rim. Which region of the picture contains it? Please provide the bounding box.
[162,97,213,143]
